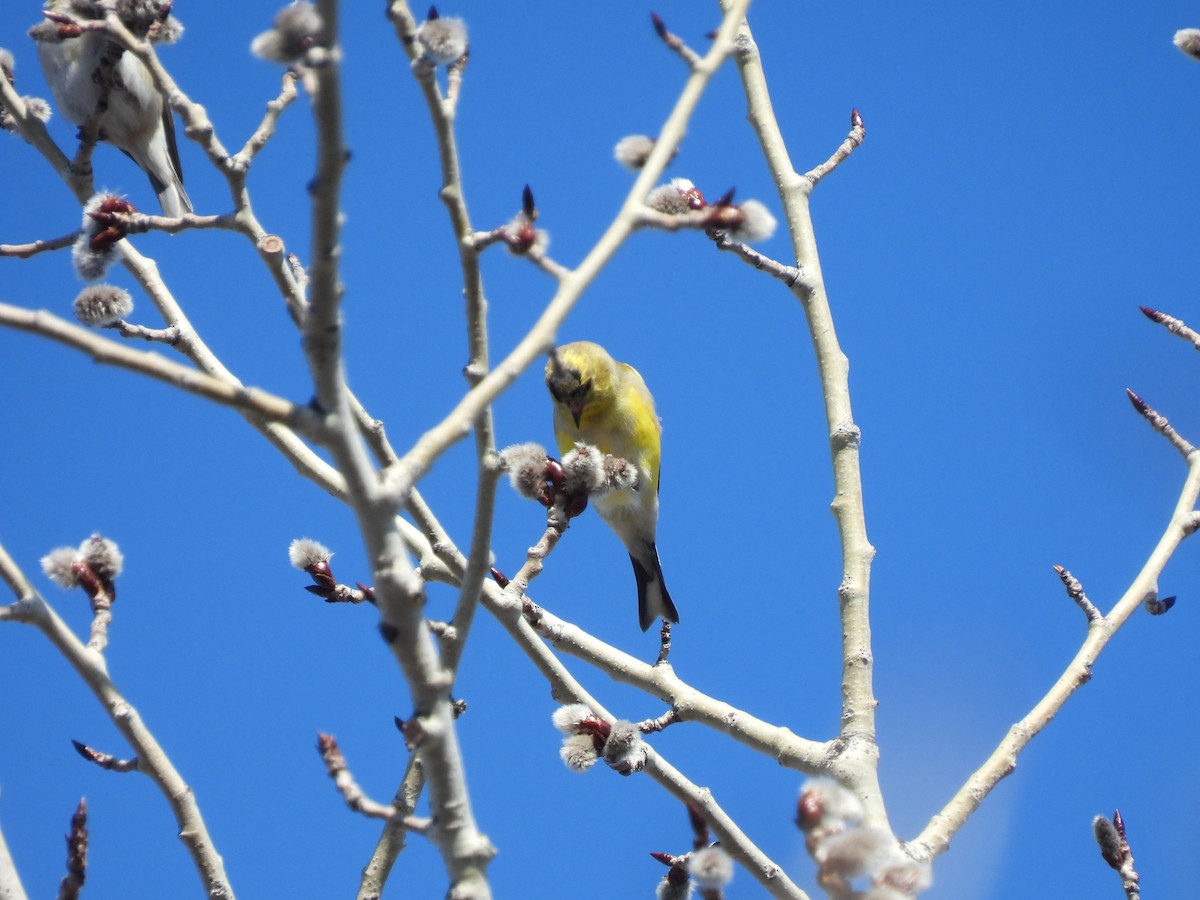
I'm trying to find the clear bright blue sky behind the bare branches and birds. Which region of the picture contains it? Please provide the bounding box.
[0,0,1200,900]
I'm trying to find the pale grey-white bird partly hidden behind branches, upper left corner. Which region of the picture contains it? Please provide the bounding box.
[29,0,192,216]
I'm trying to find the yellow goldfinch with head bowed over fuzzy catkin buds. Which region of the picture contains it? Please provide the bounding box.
[546,341,679,631]
